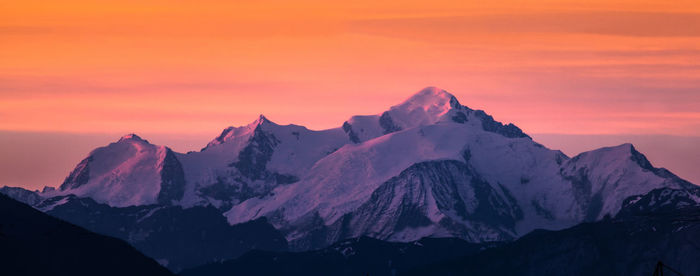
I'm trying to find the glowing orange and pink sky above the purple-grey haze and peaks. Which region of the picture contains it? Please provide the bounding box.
[0,0,700,138]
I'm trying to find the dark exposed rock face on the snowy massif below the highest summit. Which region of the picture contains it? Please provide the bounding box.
[284,160,523,249]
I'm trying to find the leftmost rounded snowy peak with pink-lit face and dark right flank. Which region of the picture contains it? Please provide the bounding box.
[54,134,185,207]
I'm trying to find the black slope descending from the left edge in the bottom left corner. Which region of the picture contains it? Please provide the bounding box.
[0,194,173,275]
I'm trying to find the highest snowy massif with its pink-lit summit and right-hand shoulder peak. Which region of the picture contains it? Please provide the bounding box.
[226,88,692,248]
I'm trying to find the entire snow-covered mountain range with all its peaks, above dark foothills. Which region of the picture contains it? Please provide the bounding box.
[16,87,695,249]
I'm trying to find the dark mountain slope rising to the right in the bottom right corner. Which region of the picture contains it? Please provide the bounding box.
[407,189,700,275]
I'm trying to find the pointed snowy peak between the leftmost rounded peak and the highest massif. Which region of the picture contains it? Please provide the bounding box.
[178,115,350,209]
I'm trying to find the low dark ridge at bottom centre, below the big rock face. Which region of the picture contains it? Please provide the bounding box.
[181,237,491,276]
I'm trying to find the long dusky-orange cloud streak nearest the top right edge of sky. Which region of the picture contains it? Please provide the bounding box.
[352,11,700,39]
